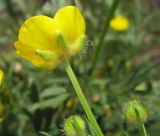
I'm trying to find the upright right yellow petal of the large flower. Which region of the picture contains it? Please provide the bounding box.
[54,6,85,44]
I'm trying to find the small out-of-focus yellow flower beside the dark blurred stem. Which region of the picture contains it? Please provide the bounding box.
[110,16,129,32]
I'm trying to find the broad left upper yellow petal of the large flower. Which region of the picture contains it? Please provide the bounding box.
[19,15,57,50]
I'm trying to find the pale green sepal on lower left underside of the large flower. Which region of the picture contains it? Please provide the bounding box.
[36,50,56,60]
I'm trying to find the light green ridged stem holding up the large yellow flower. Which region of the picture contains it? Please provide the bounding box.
[64,59,103,136]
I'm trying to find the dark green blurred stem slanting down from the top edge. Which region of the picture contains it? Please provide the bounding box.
[91,0,119,73]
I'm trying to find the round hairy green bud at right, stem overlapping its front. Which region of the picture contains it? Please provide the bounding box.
[123,100,149,124]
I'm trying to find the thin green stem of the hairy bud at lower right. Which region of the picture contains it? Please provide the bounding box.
[135,109,147,136]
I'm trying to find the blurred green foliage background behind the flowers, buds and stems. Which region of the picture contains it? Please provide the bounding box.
[0,0,160,136]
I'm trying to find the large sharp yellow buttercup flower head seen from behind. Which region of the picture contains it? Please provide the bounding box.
[15,6,85,69]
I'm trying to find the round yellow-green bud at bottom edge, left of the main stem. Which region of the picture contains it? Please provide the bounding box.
[64,115,85,136]
